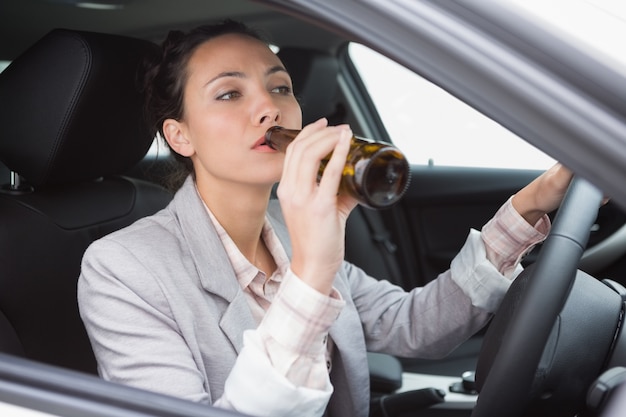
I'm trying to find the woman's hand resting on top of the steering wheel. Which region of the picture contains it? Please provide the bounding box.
[512,164,573,226]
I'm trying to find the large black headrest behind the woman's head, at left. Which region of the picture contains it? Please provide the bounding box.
[0,29,158,187]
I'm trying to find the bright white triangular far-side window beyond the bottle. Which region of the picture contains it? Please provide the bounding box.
[348,44,554,169]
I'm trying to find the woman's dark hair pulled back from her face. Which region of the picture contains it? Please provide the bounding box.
[143,19,267,190]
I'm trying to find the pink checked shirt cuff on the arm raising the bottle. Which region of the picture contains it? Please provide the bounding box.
[258,270,345,357]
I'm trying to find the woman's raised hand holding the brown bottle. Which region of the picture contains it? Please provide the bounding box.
[277,119,357,294]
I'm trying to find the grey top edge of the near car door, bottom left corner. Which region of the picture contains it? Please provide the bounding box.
[0,353,246,417]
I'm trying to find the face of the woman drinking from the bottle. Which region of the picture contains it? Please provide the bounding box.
[164,34,302,192]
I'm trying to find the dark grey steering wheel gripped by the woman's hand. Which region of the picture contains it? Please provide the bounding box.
[472,177,621,417]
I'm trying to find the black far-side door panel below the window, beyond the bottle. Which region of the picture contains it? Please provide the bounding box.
[384,166,540,286]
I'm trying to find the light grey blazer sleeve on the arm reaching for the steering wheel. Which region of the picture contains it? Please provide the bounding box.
[346,228,510,359]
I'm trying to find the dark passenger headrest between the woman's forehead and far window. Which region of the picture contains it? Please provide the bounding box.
[277,47,339,124]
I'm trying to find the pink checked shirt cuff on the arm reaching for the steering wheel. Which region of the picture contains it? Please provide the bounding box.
[481,197,550,278]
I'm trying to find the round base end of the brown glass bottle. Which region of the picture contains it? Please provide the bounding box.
[354,147,411,209]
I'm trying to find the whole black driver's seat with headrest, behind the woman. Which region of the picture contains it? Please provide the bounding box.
[0,29,171,373]
